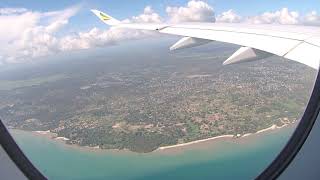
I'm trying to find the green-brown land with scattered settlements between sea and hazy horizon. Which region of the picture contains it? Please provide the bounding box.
[0,41,316,152]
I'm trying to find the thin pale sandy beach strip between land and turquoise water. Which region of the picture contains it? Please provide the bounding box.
[14,123,295,152]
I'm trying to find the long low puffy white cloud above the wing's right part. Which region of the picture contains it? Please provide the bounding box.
[246,8,300,25]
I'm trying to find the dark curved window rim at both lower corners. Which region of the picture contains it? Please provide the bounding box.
[0,69,320,180]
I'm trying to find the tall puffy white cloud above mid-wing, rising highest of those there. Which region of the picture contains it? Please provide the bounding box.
[166,0,215,23]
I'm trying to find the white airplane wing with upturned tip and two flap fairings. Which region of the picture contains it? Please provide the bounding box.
[91,10,320,69]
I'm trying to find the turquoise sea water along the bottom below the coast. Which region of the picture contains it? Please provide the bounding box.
[12,127,293,180]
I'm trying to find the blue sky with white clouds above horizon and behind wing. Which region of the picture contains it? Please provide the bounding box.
[0,0,320,66]
